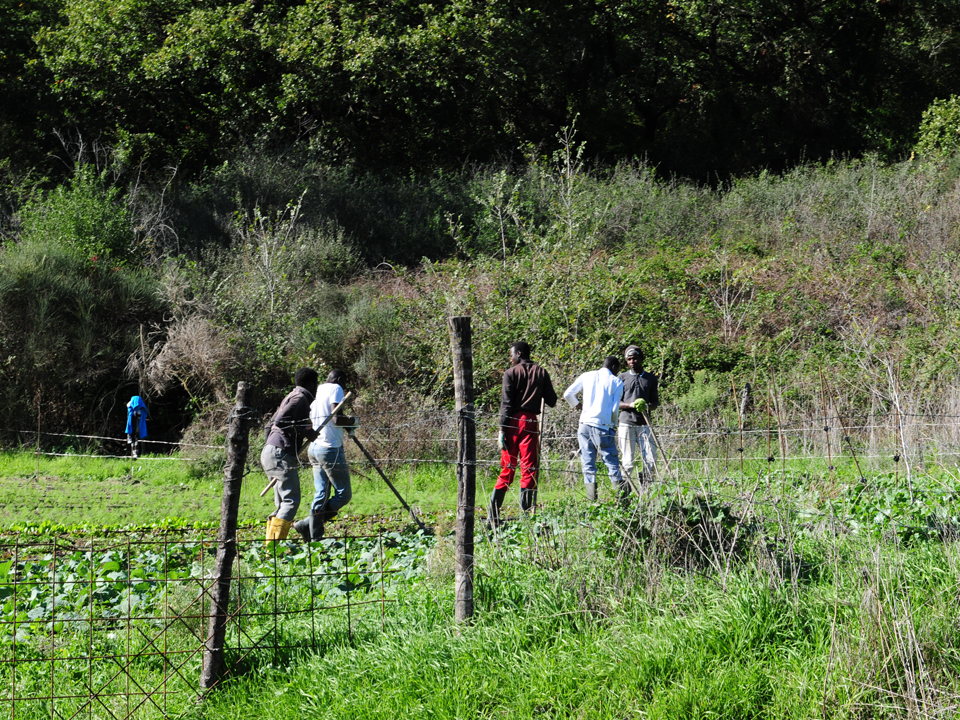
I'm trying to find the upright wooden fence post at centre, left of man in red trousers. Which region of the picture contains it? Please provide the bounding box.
[448,317,477,623]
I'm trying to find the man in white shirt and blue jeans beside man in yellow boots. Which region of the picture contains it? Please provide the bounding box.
[293,369,356,542]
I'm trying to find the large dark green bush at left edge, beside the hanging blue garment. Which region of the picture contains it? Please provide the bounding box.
[0,241,165,432]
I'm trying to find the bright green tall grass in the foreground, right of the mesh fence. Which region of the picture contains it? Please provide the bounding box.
[193,496,960,718]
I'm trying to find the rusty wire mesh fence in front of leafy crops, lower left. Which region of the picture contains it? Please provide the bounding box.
[0,532,417,719]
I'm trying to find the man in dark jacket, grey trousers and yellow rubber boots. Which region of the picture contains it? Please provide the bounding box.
[260,368,319,540]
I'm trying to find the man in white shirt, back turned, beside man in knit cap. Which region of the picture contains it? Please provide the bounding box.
[563,355,630,502]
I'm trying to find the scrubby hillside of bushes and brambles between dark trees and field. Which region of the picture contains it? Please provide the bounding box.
[0,140,960,437]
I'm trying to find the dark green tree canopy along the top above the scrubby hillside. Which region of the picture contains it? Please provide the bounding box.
[0,0,960,178]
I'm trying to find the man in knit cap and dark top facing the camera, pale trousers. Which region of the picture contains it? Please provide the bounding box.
[617,345,660,488]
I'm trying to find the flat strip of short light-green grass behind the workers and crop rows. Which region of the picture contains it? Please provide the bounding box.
[0,452,600,528]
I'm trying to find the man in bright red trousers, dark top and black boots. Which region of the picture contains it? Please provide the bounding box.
[489,342,557,527]
